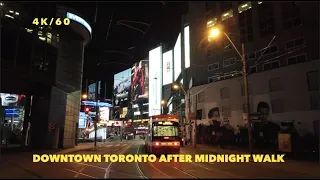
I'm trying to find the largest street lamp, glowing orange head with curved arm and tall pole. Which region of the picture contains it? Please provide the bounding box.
[209,28,253,154]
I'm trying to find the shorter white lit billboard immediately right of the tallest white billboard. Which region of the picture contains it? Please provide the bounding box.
[162,50,173,85]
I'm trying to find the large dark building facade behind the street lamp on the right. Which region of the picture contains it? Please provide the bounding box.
[184,1,320,132]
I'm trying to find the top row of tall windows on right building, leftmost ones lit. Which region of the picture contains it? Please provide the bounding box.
[207,2,302,42]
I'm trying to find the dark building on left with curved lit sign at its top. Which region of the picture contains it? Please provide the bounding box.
[1,2,91,148]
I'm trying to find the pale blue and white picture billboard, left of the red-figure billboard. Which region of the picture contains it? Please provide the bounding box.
[113,69,131,99]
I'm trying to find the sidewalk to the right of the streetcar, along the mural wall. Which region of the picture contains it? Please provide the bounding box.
[185,144,320,177]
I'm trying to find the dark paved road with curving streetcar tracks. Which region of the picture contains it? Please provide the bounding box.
[0,140,320,179]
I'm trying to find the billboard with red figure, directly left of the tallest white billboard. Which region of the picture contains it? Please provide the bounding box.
[131,60,149,104]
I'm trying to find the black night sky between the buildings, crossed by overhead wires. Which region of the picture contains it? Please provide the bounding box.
[60,1,187,98]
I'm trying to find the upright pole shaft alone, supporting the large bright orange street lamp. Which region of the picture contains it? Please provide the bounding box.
[241,43,253,154]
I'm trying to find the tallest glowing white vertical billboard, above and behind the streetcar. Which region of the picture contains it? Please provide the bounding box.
[149,46,162,116]
